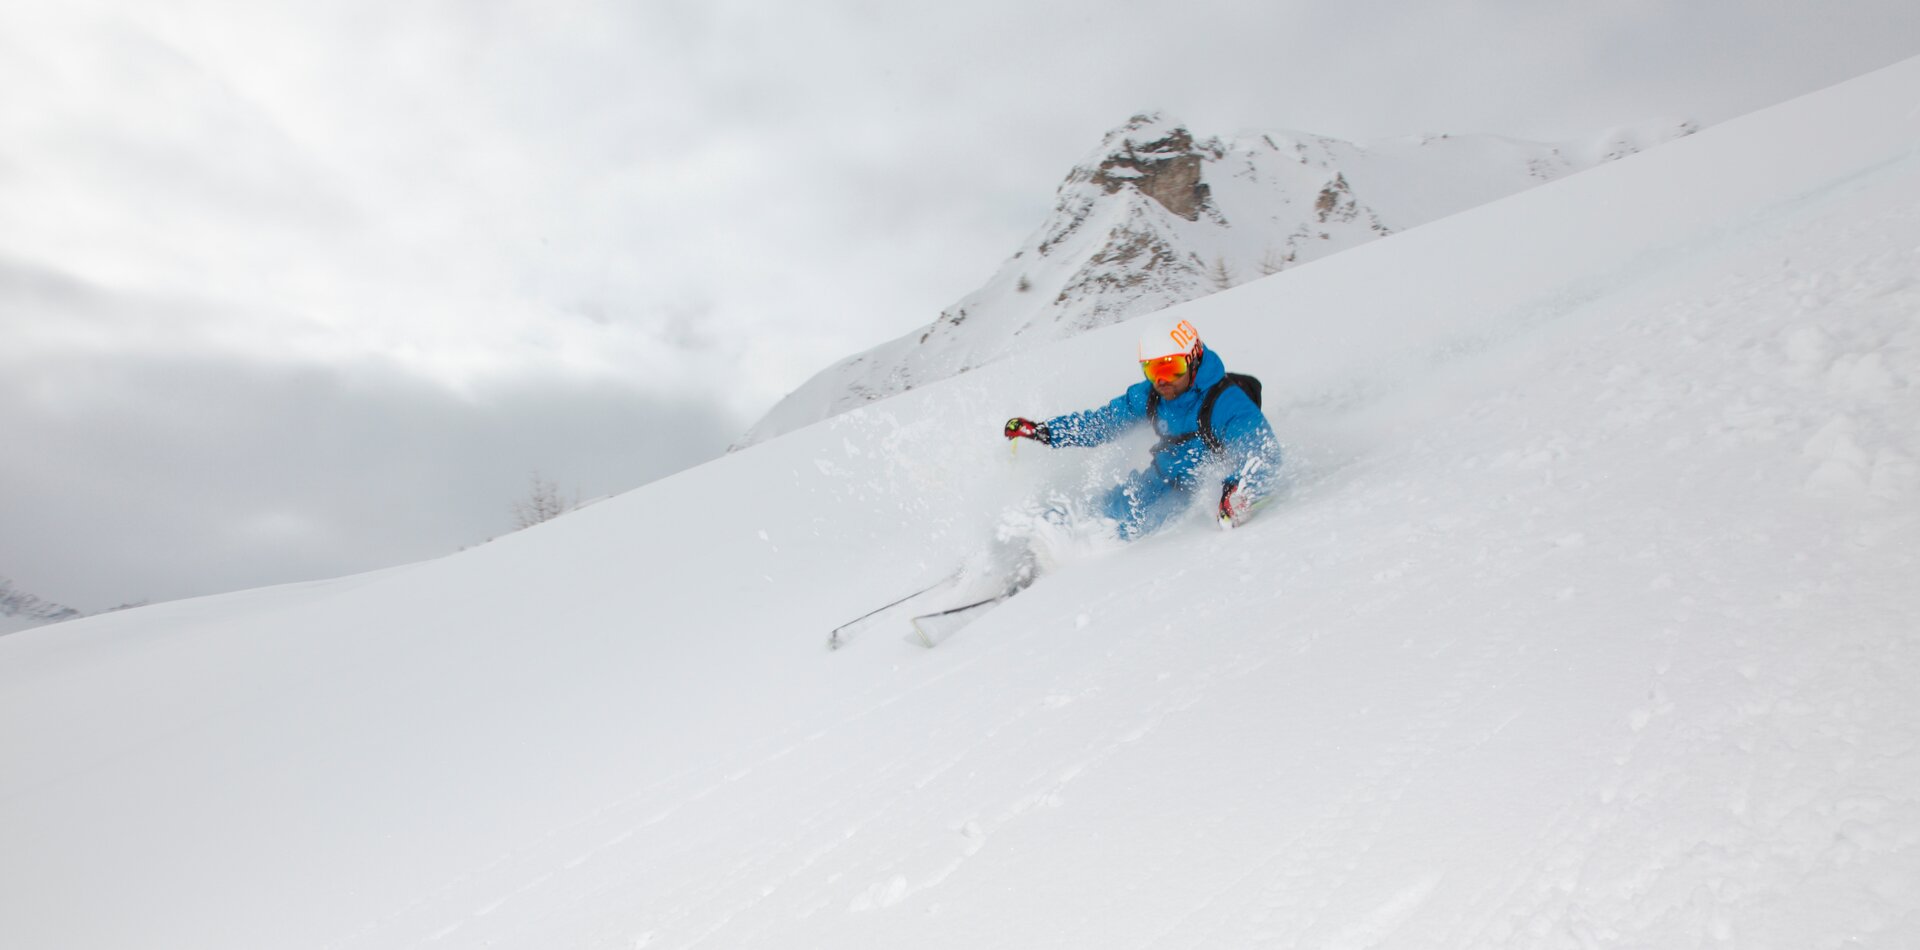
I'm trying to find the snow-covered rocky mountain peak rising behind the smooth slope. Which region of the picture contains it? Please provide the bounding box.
[741,115,1695,445]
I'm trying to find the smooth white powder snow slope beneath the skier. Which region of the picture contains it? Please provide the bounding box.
[11,59,1920,948]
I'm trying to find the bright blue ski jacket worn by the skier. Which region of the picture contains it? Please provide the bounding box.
[1046,349,1281,505]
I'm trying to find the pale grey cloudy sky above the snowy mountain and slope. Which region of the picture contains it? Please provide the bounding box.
[11,0,1920,610]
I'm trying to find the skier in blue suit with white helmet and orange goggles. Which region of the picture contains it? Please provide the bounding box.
[1006,317,1281,541]
